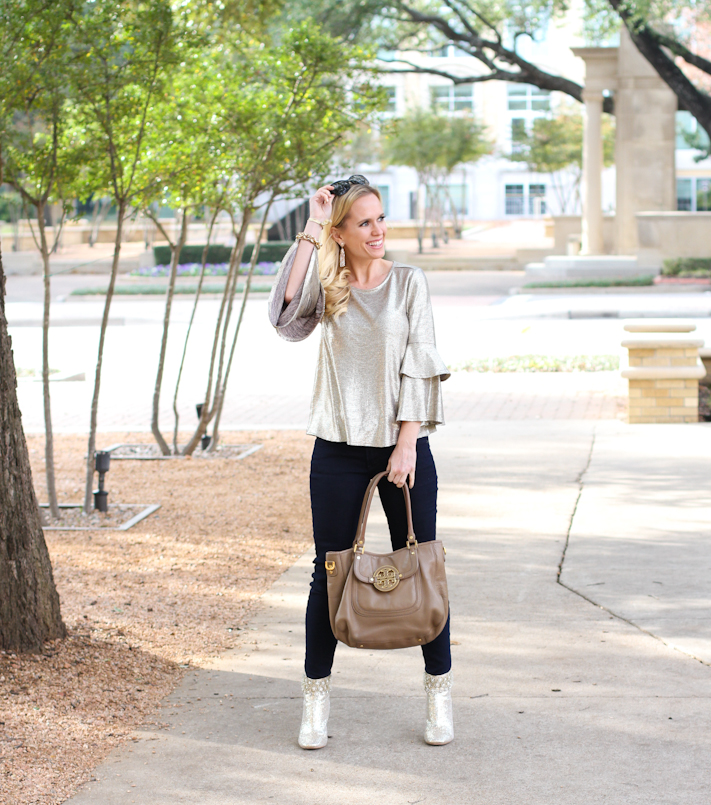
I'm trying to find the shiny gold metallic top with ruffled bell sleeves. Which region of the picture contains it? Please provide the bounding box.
[269,244,449,447]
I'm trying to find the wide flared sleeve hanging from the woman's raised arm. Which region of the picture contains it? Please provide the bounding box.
[269,241,326,341]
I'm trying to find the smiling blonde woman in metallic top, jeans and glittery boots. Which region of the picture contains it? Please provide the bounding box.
[269,176,454,749]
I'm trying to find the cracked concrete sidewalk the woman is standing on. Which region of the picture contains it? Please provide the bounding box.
[64,421,711,805]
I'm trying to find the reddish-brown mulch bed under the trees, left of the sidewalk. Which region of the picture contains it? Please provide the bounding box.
[0,431,313,805]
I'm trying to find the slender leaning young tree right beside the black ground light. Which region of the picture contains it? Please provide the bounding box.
[67,0,184,511]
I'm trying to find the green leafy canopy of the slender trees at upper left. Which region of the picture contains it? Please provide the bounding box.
[0,0,382,221]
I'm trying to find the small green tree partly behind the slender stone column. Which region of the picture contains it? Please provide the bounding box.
[510,109,615,215]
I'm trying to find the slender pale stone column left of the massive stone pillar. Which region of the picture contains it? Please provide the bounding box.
[580,89,604,254]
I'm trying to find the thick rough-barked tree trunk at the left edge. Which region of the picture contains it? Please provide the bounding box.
[0,217,66,651]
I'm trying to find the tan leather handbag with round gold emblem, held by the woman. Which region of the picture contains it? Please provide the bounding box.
[326,472,449,649]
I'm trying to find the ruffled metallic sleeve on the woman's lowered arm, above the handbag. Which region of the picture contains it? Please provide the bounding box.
[397,271,450,428]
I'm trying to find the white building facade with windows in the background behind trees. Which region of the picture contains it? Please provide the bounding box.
[358,17,615,221]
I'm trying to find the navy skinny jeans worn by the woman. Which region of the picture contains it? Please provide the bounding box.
[304,437,452,679]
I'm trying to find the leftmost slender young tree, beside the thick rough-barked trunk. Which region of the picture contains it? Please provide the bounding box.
[0,2,77,517]
